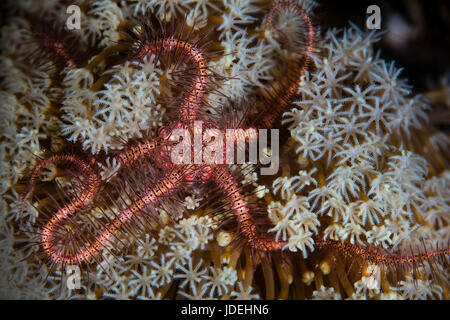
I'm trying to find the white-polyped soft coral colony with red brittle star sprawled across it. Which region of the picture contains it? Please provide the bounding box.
[0,0,450,299]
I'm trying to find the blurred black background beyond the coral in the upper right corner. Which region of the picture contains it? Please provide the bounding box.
[317,0,450,92]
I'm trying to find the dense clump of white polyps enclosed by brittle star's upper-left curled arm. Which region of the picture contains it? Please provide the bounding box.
[61,56,164,154]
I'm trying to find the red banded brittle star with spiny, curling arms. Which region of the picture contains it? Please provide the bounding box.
[24,2,449,278]
